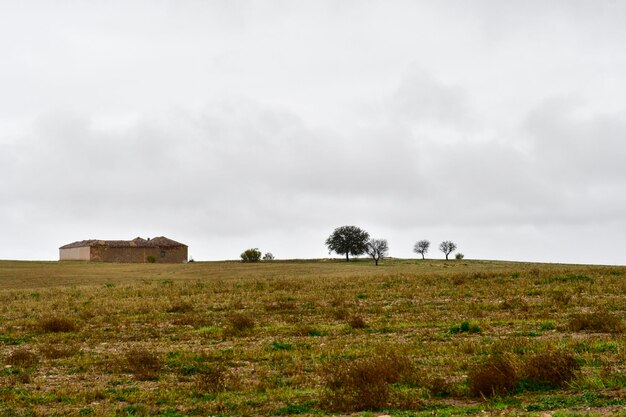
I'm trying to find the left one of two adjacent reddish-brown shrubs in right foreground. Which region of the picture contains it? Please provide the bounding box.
[468,355,518,397]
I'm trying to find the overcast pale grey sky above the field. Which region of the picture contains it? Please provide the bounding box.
[0,0,626,264]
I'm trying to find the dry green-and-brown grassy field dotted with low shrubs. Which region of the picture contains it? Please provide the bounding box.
[0,260,626,417]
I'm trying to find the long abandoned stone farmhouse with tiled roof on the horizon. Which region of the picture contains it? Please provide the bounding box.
[59,236,187,263]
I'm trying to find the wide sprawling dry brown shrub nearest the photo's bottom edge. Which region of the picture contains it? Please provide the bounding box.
[322,353,414,412]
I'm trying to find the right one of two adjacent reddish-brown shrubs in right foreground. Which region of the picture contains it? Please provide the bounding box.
[521,351,580,389]
